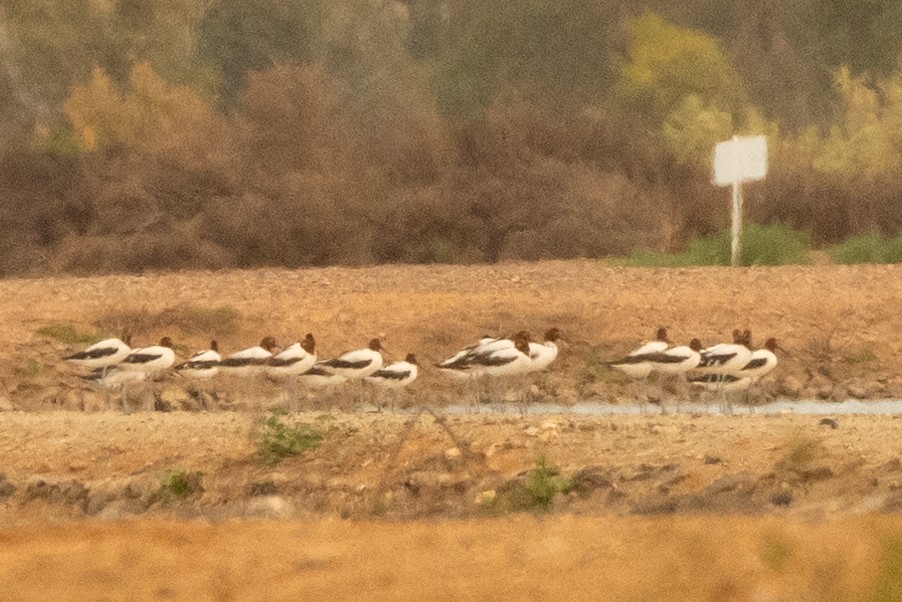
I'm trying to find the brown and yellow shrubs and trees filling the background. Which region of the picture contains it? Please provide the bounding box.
[0,0,902,276]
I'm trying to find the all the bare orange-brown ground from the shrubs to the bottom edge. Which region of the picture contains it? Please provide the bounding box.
[0,262,902,600]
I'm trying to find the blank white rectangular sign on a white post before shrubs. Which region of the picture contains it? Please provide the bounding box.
[714,136,767,266]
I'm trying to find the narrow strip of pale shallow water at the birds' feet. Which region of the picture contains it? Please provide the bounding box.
[442,399,902,416]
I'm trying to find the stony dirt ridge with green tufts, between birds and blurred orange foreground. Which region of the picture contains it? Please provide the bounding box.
[0,412,902,521]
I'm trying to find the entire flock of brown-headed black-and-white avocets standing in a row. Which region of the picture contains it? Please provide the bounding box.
[64,328,779,412]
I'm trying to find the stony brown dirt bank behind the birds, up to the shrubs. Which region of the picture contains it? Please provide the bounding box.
[0,261,902,411]
